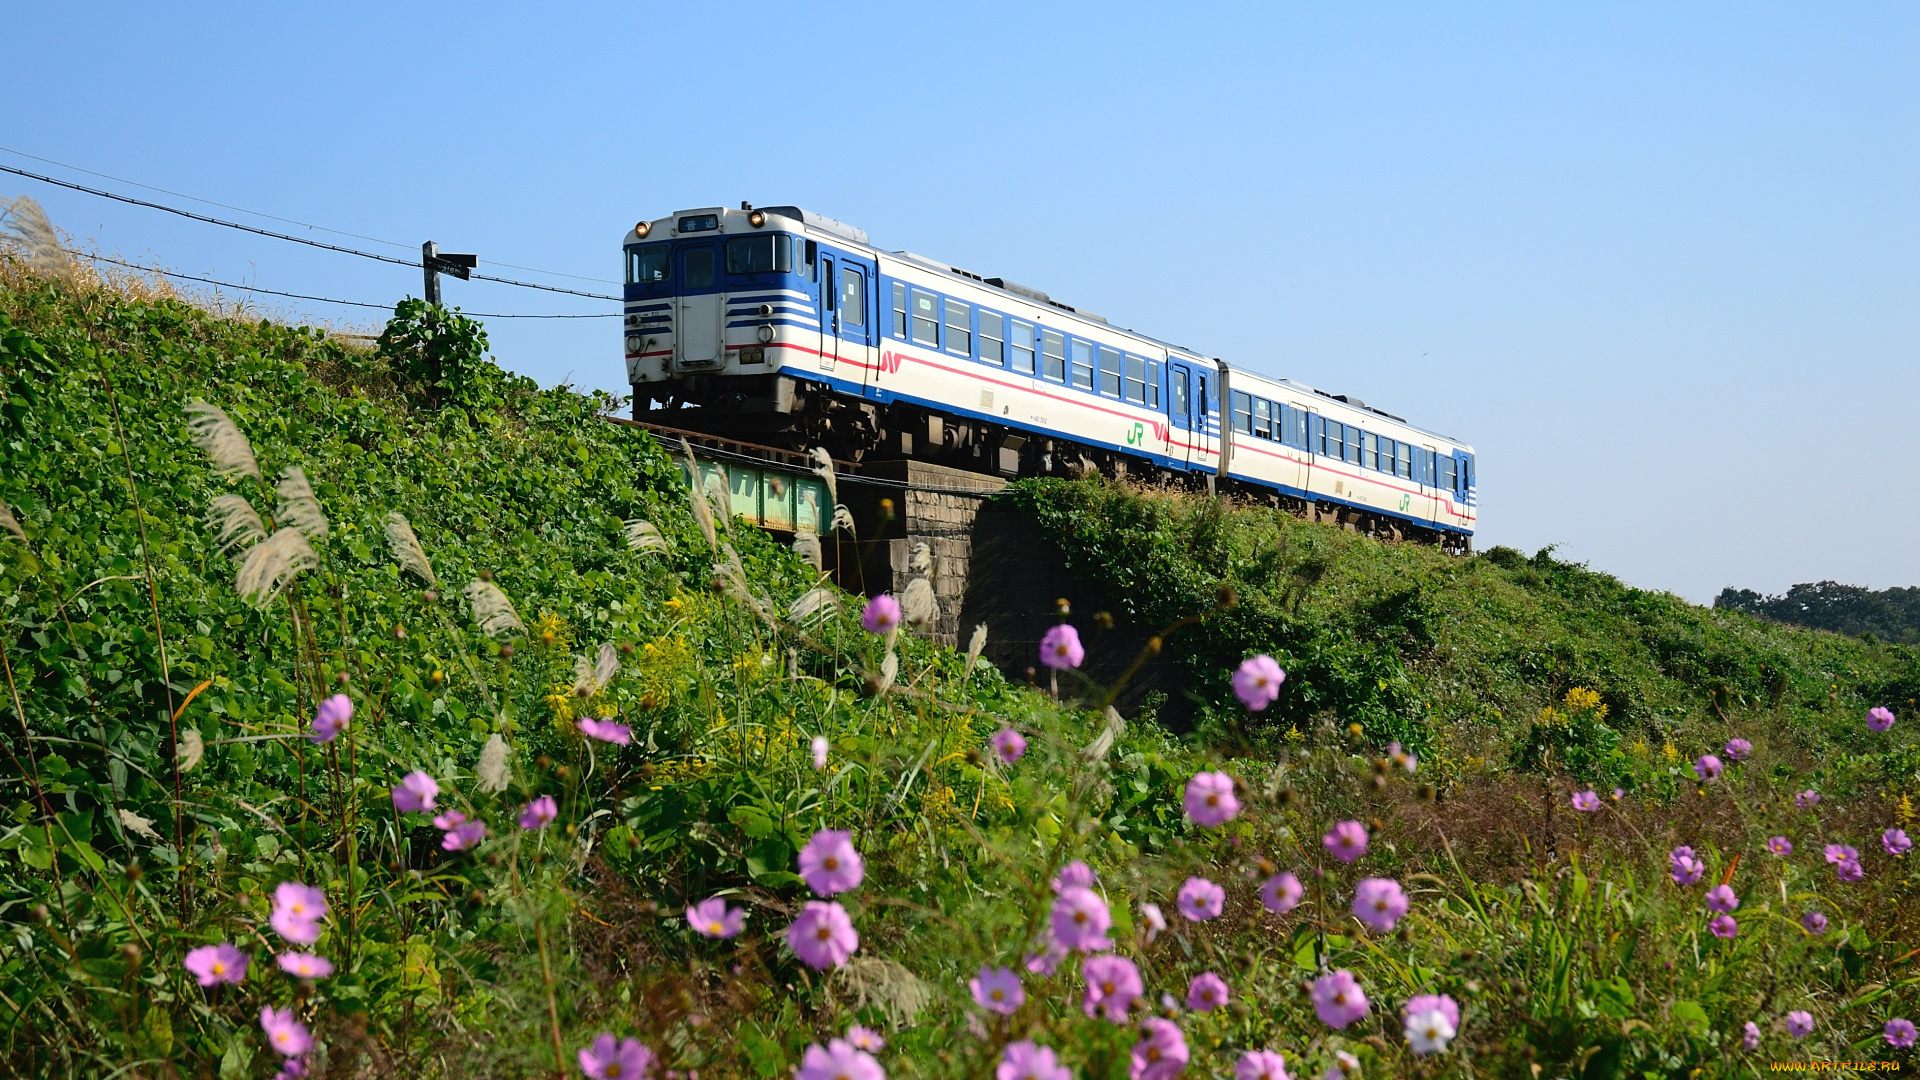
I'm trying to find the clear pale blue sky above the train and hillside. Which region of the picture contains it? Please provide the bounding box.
[0,4,1920,600]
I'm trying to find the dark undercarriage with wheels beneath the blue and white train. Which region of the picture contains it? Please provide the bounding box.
[634,373,1473,555]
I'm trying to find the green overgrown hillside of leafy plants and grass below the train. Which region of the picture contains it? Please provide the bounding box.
[0,258,1920,1080]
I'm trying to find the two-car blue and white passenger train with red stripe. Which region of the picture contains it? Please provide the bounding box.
[626,204,1476,552]
